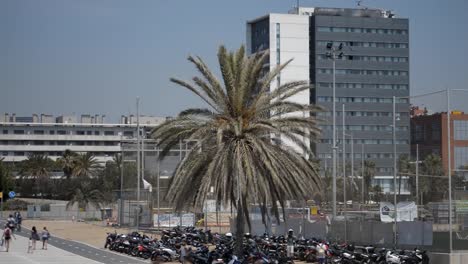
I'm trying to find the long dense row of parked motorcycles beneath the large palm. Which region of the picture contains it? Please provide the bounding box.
[105,227,429,264]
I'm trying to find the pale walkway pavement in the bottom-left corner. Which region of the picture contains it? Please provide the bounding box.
[0,236,100,264]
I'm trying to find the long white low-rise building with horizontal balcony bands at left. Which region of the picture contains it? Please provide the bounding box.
[0,114,166,163]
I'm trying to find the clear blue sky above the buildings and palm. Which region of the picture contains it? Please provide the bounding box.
[0,0,468,121]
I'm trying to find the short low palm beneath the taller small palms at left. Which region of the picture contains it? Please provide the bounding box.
[66,181,105,220]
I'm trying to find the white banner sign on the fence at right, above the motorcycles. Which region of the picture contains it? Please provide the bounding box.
[380,202,418,223]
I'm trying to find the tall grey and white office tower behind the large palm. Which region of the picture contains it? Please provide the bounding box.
[247,7,410,192]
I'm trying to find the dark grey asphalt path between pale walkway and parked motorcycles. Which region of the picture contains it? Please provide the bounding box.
[0,221,150,264]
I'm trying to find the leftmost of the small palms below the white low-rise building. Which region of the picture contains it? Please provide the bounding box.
[19,154,54,197]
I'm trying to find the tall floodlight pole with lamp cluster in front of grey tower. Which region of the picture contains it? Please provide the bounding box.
[328,41,343,219]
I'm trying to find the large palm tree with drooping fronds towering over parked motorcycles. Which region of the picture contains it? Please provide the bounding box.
[152,46,320,254]
